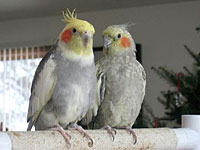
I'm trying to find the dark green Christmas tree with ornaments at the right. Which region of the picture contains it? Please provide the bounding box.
[152,27,200,126]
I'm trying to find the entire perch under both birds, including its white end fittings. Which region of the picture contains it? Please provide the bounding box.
[0,115,200,150]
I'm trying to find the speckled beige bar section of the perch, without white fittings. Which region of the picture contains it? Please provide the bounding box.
[0,128,177,150]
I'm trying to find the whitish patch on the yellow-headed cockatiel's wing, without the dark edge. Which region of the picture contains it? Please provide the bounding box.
[27,57,56,121]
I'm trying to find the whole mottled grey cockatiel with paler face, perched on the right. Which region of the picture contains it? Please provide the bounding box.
[83,25,146,142]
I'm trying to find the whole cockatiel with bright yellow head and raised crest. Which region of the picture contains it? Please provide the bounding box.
[27,10,96,144]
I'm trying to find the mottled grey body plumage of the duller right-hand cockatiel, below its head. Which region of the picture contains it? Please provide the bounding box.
[94,51,146,128]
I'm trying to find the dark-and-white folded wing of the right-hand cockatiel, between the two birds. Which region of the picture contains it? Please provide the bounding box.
[81,59,106,125]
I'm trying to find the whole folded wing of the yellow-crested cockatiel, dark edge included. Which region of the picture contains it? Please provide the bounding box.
[27,50,56,130]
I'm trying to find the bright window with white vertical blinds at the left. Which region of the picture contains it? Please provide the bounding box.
[0,47,41,131]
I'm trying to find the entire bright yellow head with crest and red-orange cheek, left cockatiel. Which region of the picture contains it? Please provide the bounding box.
[59,9,95,57]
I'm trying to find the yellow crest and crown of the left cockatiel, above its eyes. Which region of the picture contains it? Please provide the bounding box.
[63,9,95,34]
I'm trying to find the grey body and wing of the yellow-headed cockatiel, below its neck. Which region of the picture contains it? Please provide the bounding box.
[27,47,96,130]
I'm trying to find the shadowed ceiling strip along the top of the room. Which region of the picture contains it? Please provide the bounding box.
[0,0,198,21]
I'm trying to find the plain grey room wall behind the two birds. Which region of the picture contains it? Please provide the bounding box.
[0,1,200,119]
